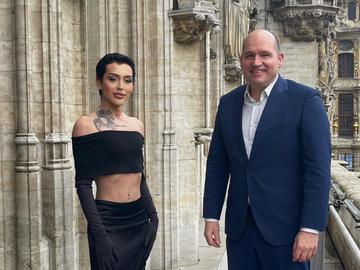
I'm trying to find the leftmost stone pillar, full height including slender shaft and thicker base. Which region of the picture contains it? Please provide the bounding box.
[14,0,41,270]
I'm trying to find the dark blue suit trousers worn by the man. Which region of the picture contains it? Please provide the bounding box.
[226,209,310,270]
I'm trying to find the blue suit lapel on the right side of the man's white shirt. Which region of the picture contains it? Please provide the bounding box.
[250,75,288,159]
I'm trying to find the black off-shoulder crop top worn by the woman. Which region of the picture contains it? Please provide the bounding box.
[72,130,144,179]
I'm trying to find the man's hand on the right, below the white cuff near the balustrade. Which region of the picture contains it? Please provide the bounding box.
[293,231,319,262]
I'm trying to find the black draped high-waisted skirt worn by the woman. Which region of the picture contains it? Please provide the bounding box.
[88,198,156,270]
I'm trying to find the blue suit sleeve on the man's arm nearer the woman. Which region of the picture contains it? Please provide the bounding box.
[203,100,230,220]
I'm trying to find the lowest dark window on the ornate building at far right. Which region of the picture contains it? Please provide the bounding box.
[338,94,354,137]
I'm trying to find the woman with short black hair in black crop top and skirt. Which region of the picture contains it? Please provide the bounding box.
[72,53,158,270]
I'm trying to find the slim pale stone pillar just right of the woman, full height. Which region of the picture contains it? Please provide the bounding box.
[164,4,180,270]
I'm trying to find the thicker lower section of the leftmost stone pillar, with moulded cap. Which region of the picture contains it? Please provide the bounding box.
[15,133,41,270]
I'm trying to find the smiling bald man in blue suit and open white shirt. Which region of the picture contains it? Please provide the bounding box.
[203,30,331,270]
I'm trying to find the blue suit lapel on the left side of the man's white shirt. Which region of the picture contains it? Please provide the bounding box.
[232,86,248,160]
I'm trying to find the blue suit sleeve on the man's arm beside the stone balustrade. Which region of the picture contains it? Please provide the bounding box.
[301,94,331,231]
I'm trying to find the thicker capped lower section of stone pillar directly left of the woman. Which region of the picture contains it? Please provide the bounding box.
[42,133,72,269]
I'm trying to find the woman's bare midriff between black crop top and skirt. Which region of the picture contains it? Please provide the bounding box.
[96,173,141,202]
